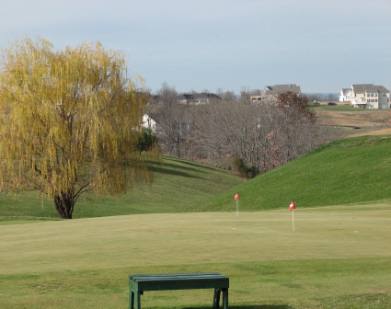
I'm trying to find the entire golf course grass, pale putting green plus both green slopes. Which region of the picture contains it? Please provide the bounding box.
[0,137,391,309]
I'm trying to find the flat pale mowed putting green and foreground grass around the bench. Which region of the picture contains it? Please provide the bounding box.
[0,204,391,309]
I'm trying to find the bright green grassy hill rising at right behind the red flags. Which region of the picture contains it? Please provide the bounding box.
[211,137,391,210]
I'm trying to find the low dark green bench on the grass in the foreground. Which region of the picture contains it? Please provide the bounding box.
[129,273,229,309]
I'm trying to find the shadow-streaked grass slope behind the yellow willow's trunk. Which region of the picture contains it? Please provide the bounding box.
[0,158,242,223]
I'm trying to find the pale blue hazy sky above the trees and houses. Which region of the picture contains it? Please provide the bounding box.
[0,0,391,93]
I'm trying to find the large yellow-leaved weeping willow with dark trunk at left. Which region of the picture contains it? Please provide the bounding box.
[0,40,152,219]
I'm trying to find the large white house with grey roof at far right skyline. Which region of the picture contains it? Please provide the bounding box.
[340,84,390,109]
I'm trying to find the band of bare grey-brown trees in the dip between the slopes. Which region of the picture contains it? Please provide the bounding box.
[148,87,327,177]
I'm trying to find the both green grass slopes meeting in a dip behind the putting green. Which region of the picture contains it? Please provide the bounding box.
[0,136,391,221]
